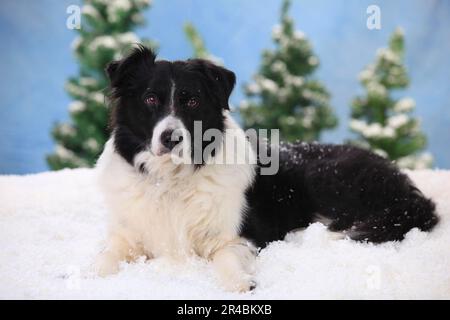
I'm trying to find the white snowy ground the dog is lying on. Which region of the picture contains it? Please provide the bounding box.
[0,169,450,299]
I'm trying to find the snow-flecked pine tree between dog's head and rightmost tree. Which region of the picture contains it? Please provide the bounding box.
[240,0,337,141]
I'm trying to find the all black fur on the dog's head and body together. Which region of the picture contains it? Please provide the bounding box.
[107,47,438,247]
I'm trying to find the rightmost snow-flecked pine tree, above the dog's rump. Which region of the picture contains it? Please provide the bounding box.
[350,28,433,169]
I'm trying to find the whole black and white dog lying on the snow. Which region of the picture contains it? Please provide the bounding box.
[96,46,438,291]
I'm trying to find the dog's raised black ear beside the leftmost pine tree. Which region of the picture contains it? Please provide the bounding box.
[105,44,156,88]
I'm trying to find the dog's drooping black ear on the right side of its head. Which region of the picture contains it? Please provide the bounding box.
[188,59,236,110]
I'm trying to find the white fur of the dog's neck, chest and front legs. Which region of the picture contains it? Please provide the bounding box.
[95,112,255,291]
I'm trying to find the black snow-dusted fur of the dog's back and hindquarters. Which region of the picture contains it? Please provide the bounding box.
[242,143,438,247]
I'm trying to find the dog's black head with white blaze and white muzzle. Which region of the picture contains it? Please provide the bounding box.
[106,46,236,169]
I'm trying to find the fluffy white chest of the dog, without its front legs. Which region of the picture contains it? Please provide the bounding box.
[99,142,253,258]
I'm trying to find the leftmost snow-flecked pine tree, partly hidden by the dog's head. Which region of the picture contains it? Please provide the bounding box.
[47,0,152,170]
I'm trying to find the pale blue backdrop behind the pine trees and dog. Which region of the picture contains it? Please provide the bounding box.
[0,0,450,174]
